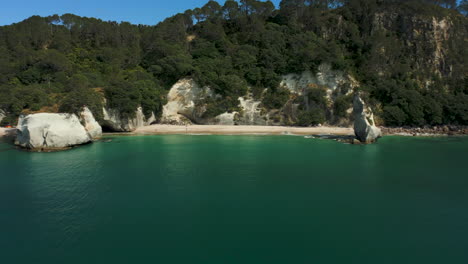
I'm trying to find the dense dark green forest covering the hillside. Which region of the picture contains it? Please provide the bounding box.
[0,0,468,126]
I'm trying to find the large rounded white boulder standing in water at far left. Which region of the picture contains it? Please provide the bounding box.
[15,113,92,150]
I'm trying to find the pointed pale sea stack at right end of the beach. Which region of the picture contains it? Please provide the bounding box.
[353,92,382,144]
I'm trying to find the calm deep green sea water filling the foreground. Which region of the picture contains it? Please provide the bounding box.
[0,136,468,264]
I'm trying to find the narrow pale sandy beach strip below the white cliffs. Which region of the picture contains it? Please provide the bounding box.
[133,125,354,135]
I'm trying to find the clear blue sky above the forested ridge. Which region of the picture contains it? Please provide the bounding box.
[0,0,280,25]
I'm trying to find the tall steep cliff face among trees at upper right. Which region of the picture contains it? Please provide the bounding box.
[372,10,467,77]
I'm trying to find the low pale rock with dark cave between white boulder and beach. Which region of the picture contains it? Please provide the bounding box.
[102,107,156,132]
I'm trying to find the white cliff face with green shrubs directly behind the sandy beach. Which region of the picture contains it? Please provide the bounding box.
[161,64,359,125]
